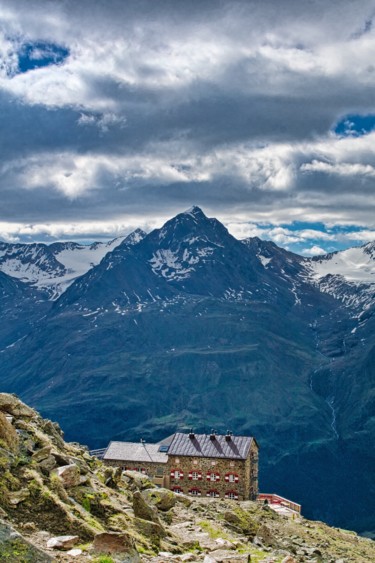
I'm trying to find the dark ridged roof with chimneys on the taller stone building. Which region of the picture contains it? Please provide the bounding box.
[168,432,254,459]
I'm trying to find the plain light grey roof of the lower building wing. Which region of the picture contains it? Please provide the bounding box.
[103,442,168,463]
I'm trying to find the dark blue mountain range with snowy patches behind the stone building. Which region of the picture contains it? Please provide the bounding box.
[0,207,375,531]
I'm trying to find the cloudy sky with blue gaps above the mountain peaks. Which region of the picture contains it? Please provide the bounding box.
[0,0,375,255]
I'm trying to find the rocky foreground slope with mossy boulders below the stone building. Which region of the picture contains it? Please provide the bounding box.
[0,393,375,563]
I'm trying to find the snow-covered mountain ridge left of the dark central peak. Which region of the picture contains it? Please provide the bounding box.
[0,229,145,300]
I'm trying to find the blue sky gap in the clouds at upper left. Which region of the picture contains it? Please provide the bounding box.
[18,41,69,73]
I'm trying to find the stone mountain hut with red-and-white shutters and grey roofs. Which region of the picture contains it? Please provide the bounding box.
[103,432,259,500]
